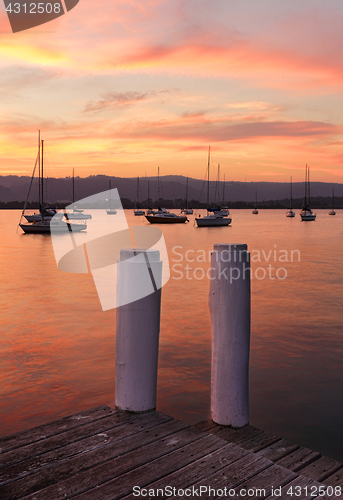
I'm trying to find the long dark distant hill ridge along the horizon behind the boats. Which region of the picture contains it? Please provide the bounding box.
[0,175,343,205]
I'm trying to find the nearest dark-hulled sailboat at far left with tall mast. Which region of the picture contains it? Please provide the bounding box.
[19,135,87,234]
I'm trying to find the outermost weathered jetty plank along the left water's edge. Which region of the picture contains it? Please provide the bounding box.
[0,405,118,453]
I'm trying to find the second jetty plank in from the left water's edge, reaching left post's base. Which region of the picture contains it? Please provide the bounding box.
[0,412,172,468]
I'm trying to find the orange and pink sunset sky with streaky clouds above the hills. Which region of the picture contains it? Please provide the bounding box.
[0,0,343,182]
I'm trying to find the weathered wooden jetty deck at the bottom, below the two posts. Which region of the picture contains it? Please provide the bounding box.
[0,405,343,500]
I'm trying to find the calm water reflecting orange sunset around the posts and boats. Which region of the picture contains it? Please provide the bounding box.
[0,210,343,461]
